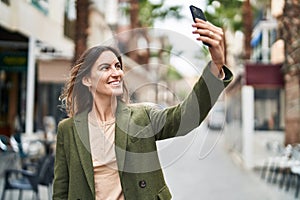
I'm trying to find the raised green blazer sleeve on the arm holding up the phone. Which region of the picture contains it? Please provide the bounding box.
[148,63,233,140]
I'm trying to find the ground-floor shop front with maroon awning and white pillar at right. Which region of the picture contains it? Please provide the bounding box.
[225,63,285,168]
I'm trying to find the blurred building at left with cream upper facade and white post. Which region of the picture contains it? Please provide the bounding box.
[0,0,74,135]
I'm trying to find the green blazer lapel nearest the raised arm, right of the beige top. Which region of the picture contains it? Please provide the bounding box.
[115,101,131,177]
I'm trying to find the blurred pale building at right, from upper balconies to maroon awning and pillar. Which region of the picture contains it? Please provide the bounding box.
[225,0,286,168]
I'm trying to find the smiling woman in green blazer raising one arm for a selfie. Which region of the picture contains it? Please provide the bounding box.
[53,19,232,200]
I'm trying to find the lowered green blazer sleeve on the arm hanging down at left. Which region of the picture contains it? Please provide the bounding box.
[53,119,69,200]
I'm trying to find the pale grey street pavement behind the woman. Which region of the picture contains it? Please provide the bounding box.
[0,124,295,200]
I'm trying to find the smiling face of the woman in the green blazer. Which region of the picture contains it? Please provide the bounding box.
[83,51,124,97]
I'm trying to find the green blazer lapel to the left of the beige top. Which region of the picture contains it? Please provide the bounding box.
[74,111,95,196]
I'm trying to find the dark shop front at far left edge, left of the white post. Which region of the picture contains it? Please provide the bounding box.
[0,27,28,136]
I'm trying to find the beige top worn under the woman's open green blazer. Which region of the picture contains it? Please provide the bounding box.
[88,112,124,200]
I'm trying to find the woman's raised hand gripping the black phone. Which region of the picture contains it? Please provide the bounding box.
[192,18,225,71]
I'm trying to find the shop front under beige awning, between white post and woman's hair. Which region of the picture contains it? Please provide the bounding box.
[35,58,71,132]
